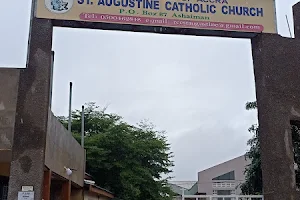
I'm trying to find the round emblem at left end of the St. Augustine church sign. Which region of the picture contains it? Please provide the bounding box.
[45,0,74,14]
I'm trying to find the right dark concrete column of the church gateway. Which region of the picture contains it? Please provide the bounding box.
[252,18,300,200]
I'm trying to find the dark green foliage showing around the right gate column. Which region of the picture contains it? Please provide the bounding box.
[241,101,300,194]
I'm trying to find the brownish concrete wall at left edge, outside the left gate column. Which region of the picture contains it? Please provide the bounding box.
[0,68,20,163]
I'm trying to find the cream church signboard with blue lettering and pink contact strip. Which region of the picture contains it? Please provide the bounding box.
[35,0,277,33]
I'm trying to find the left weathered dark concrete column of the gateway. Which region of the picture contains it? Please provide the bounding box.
[8,0,53,200]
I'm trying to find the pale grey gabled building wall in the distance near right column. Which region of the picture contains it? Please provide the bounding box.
[198,156,250,195]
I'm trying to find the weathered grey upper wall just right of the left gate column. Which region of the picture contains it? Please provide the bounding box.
[45,112,85,186]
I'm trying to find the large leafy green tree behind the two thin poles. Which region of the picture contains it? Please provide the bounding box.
[60,103,173,200]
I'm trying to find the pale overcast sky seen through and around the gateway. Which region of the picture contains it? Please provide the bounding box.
[0,0,296,181]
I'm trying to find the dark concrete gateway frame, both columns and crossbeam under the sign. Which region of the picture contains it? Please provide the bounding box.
[3,0,300,200]
